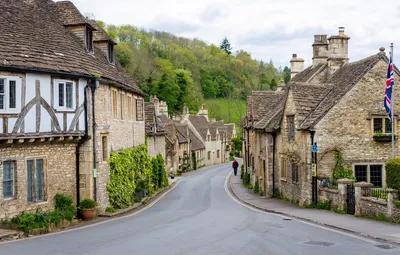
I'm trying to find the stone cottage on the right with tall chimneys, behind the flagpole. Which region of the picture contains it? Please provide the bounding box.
[244,27,400,204]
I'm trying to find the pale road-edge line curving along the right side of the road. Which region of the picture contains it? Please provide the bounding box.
[224,171,382,245]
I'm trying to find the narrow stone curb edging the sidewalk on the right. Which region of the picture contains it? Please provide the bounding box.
[227,173,400,245]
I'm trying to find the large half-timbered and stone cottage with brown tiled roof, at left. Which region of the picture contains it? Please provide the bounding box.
[0,0,144,218]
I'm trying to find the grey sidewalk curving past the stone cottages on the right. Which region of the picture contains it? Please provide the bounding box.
[229,175,400,244]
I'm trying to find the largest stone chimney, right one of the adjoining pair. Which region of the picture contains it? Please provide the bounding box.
[328,27,350,75]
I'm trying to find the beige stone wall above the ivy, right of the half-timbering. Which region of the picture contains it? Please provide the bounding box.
[80,84,145,208]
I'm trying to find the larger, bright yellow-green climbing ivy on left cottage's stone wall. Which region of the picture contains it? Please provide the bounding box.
[107,145,154,208]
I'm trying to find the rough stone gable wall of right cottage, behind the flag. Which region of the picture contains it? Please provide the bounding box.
[315,60,400,185]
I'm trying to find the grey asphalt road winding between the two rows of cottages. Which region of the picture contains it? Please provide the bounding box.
[0,162,400,255]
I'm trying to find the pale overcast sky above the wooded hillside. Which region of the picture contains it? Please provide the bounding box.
[61,0,400,66]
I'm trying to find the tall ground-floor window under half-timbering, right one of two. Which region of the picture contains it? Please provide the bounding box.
[27,159,45,203]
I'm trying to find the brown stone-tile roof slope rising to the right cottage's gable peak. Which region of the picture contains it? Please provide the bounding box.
[300,53,384,129]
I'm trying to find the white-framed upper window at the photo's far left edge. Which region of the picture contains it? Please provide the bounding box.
[0,76,21,113]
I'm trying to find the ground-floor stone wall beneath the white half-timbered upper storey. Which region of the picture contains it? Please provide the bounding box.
[0,142,76,219]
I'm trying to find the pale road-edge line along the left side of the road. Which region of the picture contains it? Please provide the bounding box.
[0,179,181,246]
